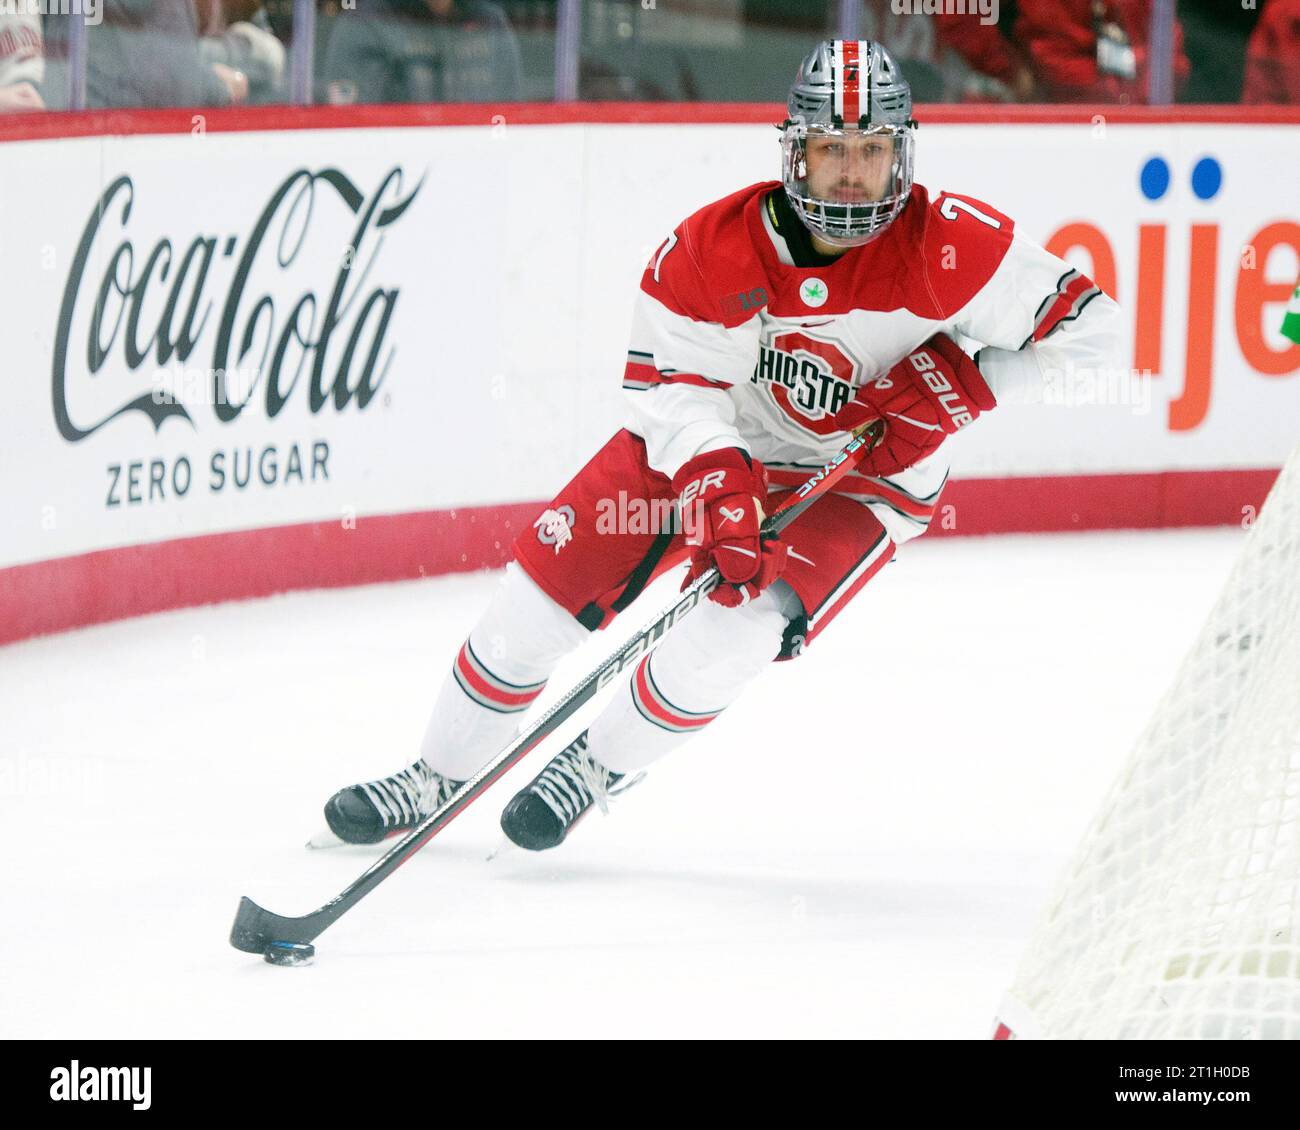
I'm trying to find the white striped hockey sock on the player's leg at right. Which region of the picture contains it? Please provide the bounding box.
[588,581,800,774]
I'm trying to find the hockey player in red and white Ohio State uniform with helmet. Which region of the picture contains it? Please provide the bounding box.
[325,40,1118,850]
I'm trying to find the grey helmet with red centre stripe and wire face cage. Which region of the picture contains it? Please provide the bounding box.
[781,39,917,247]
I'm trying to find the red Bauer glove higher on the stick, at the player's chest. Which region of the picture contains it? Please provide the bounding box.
[835,333,997,475]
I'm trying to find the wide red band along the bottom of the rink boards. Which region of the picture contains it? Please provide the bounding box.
[0,469,1278,644]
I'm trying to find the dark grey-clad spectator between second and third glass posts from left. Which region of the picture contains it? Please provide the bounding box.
[324,0,521,103]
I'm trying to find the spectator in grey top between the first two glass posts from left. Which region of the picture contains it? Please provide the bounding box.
[46,0,248,107]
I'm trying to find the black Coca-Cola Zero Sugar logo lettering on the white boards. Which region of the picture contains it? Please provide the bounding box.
[51,168,408,508]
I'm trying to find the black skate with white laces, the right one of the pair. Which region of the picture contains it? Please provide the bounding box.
[501,733,641,852]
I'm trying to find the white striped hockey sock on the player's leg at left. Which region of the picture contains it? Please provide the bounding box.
[420,562,588,780]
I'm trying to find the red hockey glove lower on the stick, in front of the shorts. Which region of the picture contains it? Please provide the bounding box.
[672,447,787,609]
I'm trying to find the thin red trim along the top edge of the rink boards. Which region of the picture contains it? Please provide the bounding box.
[0,101,1300,142]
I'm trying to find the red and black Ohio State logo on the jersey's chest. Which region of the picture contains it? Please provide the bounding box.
[750,330,858,436]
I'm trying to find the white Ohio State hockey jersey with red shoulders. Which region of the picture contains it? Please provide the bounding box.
[624,182,1119,542]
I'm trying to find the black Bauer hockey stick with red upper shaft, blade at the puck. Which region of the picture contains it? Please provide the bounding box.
[230,421,884,953]
